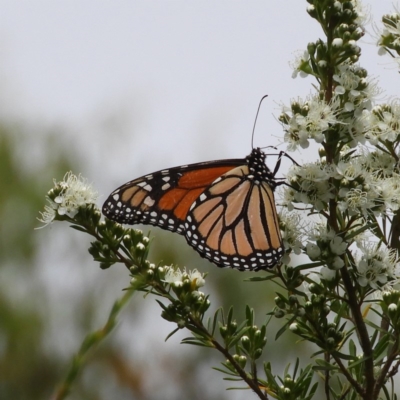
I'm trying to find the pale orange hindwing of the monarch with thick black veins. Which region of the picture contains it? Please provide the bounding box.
[185,154,284,271]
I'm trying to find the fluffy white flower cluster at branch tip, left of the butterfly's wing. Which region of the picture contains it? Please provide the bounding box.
[38,172,98,228]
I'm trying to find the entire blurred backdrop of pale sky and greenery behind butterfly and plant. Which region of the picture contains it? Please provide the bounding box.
[0,0,399,400]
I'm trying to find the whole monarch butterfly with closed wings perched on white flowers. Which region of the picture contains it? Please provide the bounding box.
[103,148,284,271]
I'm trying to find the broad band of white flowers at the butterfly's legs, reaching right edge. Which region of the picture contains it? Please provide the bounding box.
[283,147,400,216]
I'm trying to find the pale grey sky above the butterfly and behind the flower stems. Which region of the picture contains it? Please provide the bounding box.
[0,0,400,192]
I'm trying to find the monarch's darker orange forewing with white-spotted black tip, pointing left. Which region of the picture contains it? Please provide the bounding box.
[103,159,244,234]
